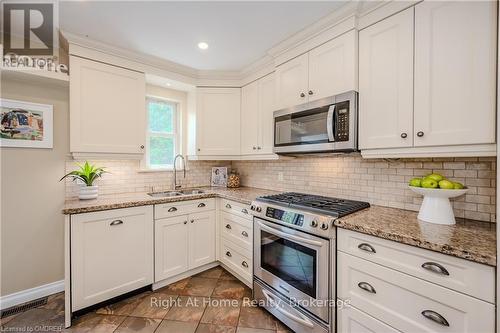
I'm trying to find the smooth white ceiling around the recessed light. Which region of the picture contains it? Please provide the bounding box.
[59,1,346,70]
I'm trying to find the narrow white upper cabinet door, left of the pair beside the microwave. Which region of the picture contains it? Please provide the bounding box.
[241,81,260,155]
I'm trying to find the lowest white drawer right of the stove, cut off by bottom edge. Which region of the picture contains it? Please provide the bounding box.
[337,306,400,333]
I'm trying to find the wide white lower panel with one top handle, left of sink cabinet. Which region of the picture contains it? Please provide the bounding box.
[71,206,153,311]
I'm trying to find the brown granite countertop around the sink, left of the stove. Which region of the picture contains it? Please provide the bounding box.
[62,187,278,214]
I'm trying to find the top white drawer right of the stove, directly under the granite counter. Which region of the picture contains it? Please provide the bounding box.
[337,229,495,303]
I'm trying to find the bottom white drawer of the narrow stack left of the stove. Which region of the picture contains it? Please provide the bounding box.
[220,238,253,282]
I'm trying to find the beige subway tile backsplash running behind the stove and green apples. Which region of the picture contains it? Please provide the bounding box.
[232,155,496,222]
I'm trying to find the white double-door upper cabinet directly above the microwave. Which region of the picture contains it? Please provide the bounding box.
[276,29,358,109]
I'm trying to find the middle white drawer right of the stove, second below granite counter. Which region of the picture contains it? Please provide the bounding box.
[337,252,495,333]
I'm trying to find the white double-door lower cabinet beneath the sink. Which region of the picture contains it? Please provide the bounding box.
[155,202,216,282]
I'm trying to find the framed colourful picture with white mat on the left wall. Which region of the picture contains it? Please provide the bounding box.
[0,99,54,148]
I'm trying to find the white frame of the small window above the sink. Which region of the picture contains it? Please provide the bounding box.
[142,96,181,171]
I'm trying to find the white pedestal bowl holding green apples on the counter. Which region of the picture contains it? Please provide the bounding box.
[408,186,468,225]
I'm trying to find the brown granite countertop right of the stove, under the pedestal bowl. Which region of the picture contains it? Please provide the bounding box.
[335,206,496,266]
